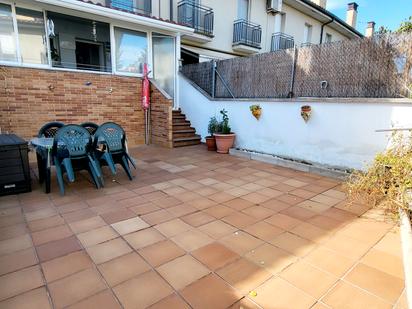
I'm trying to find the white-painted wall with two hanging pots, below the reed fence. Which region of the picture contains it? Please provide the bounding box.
[179,76,412,169]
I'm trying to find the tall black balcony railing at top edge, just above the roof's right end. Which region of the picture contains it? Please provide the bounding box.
[177,0,214,36]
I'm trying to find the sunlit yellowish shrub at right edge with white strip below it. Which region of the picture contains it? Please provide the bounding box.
[345,130,412,306]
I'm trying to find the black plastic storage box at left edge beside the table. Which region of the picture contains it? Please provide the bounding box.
[0,134,31,195]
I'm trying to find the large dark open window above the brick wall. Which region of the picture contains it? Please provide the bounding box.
[47,12,112,72]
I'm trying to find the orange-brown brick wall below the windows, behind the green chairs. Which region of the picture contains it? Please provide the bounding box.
[0,67,173,146]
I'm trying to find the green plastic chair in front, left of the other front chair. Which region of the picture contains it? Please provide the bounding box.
[53,124,101,195]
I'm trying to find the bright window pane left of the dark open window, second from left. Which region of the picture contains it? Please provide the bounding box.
[16,8,48,64]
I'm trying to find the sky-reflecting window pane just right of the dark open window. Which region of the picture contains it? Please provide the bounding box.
[114,28,147,74]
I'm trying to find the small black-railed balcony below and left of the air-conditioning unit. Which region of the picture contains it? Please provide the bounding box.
[233,19,262,53]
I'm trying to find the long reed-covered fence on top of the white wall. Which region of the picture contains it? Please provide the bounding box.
[182,34,412,98]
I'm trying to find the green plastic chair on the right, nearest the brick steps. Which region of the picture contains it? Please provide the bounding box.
[93,122,136,180]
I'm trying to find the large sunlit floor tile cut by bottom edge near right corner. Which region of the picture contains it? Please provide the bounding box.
[322,281,392,309]
